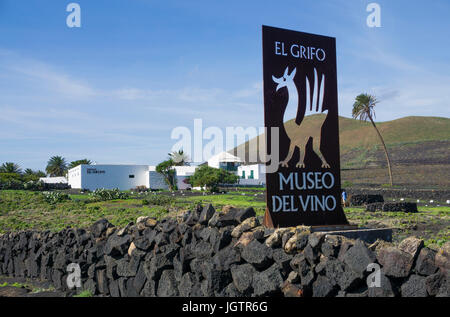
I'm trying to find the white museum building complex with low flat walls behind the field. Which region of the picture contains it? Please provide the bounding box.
[68,152,266,190]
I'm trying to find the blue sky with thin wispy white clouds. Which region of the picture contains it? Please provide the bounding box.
[0,0,450,169]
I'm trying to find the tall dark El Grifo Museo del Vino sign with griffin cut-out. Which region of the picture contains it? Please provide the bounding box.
[263,26,348,227]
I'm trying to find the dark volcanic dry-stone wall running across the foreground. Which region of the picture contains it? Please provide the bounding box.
[0,205,450,297]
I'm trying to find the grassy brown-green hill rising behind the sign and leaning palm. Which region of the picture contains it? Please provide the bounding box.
[230,115,450,188]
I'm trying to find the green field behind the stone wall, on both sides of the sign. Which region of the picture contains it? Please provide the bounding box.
[0,188,450,248]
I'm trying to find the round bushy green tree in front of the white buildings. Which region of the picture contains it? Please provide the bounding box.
[189,165,239,192]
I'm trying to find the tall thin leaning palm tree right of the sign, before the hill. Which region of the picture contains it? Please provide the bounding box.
[352,94,393,186]
